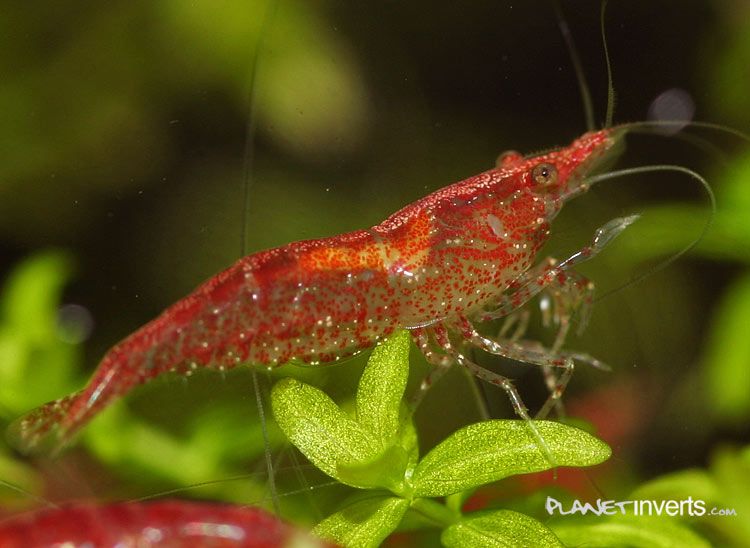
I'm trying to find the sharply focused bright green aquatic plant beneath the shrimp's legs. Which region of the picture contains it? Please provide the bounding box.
[271,332,611,547]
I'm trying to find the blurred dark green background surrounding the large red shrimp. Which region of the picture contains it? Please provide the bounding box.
[0,0,750,544]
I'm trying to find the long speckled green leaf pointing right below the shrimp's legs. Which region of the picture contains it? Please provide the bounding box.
[412,420,611,497]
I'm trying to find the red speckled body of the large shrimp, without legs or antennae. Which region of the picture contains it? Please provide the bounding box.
[11,129,617,447]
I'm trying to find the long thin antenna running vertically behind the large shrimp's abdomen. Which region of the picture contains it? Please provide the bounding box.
[240,0,280,515]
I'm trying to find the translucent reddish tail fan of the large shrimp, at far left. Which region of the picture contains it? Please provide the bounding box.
[6,391,87,455]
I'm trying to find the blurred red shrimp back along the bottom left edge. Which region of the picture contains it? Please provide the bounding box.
[0,500,314,548]
